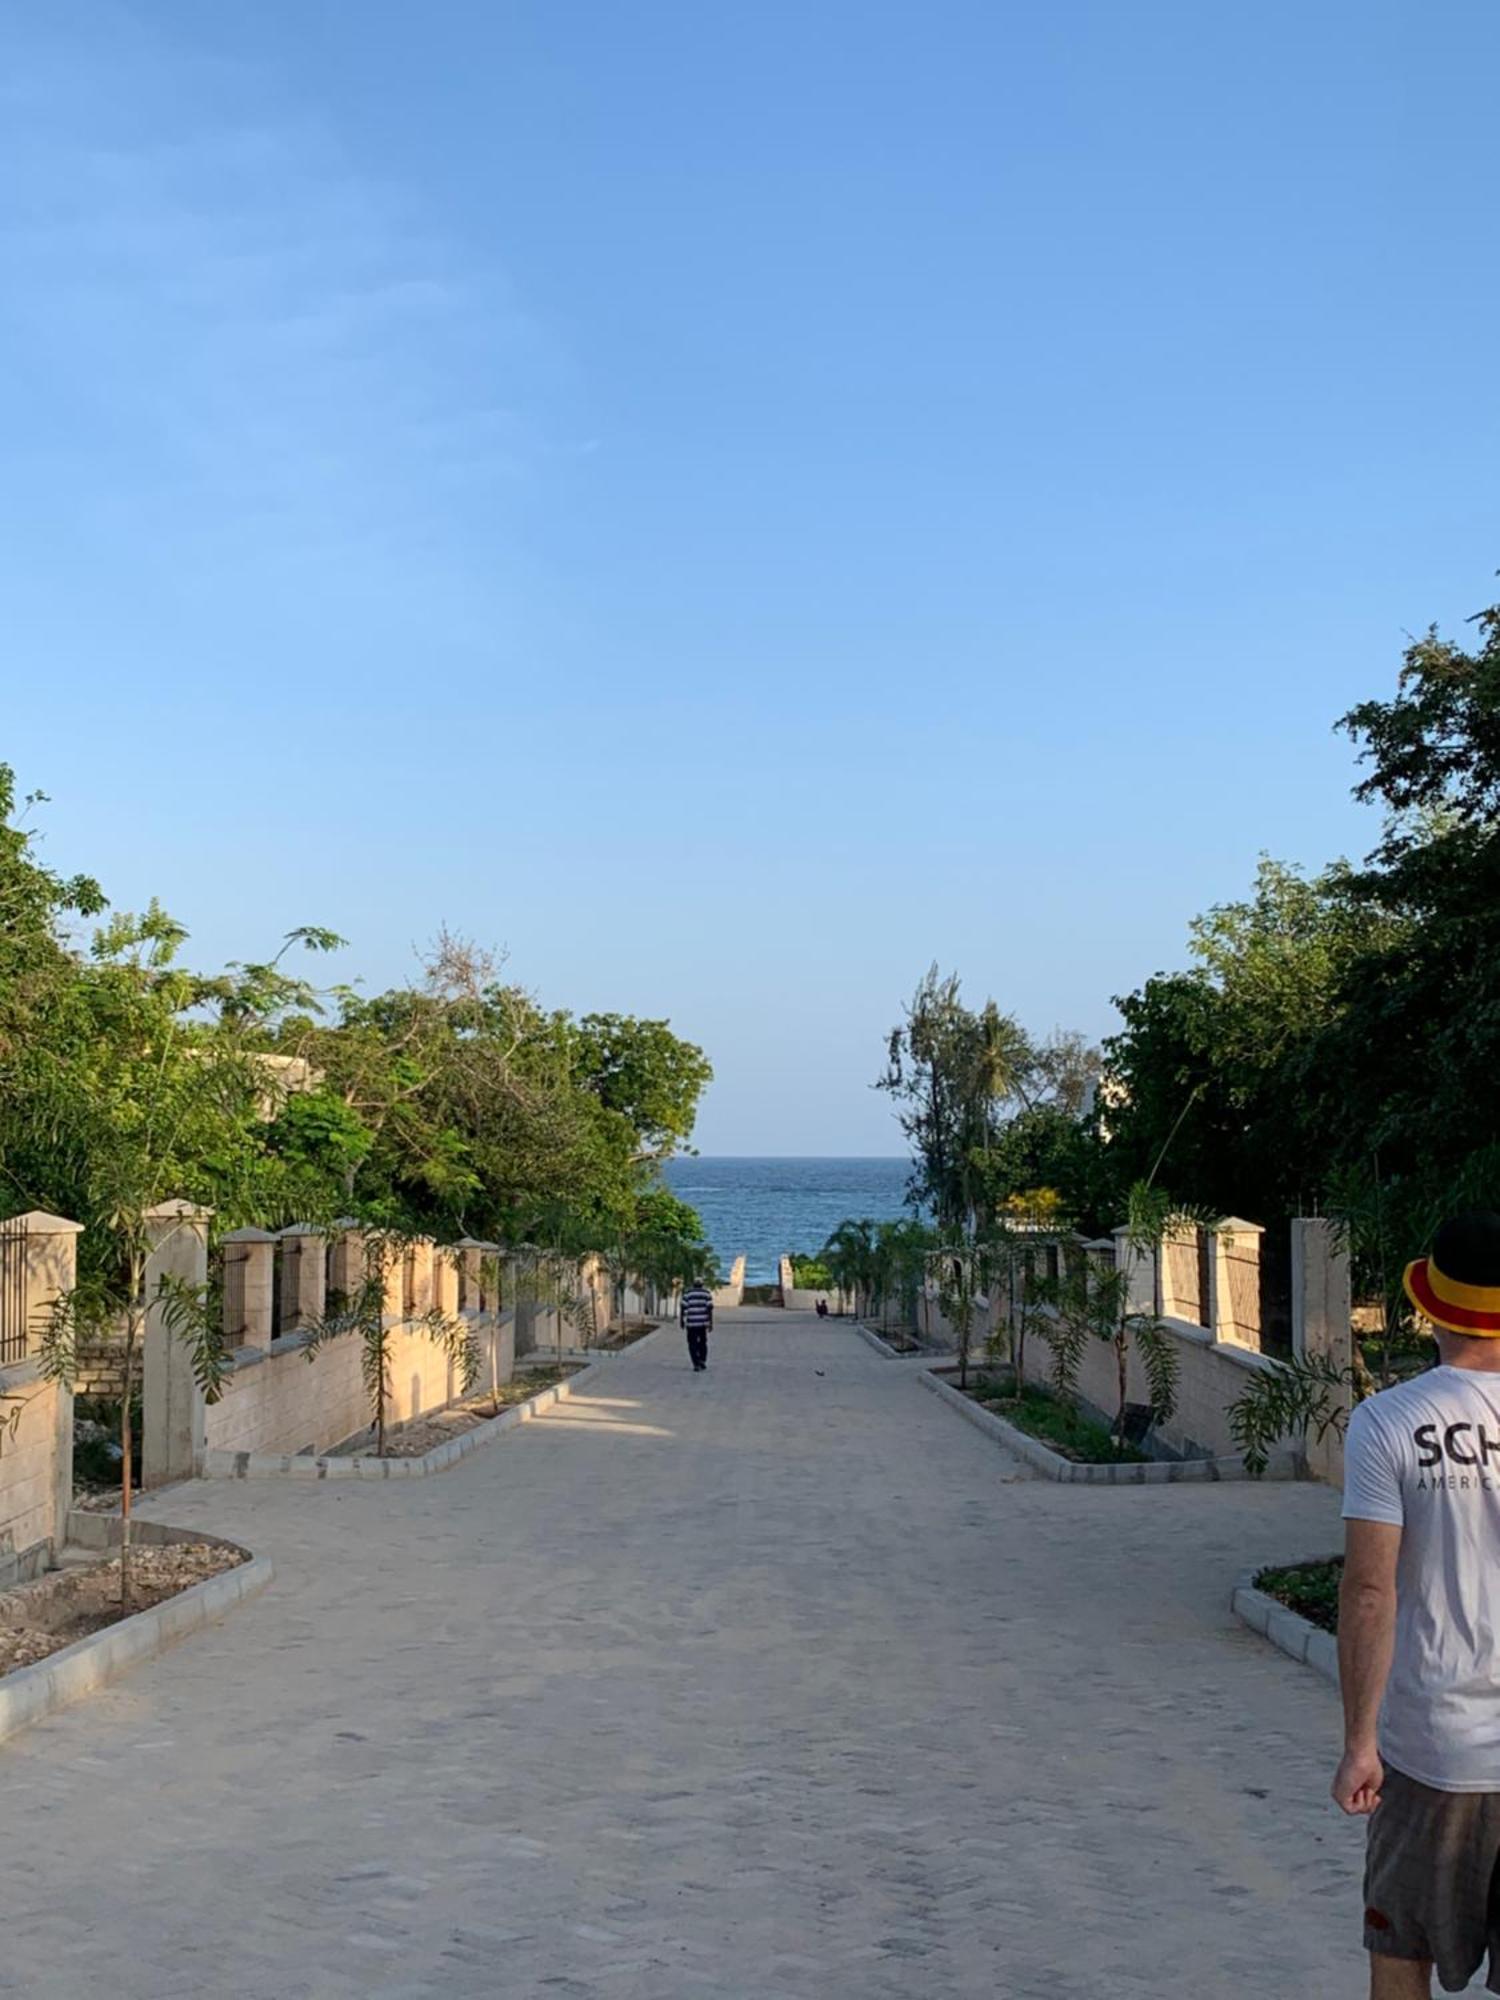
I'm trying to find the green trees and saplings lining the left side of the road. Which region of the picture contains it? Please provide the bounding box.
[0,766,714,1596]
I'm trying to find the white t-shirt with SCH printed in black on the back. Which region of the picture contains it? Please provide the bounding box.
[1344,1368,1500,1792]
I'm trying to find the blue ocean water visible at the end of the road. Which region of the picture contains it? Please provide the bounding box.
[666,1158,912,1284]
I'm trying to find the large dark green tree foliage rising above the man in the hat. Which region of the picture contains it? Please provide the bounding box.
[1106,592,1500,1280]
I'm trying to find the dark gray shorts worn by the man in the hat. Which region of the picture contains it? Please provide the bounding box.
[1364,1764,1500,1994]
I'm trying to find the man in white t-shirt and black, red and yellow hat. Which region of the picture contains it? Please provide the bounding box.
[1334,1208,1500,2000]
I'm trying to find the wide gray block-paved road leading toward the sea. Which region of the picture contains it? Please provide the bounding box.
[0,1310,1364,2000]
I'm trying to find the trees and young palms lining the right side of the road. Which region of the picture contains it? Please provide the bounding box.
[822,584,1500,1470]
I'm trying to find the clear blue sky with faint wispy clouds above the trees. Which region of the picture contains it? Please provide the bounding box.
[0,0,1500,1152]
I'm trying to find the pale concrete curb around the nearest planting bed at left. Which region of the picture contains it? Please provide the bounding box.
[0,1514,274,1742]
